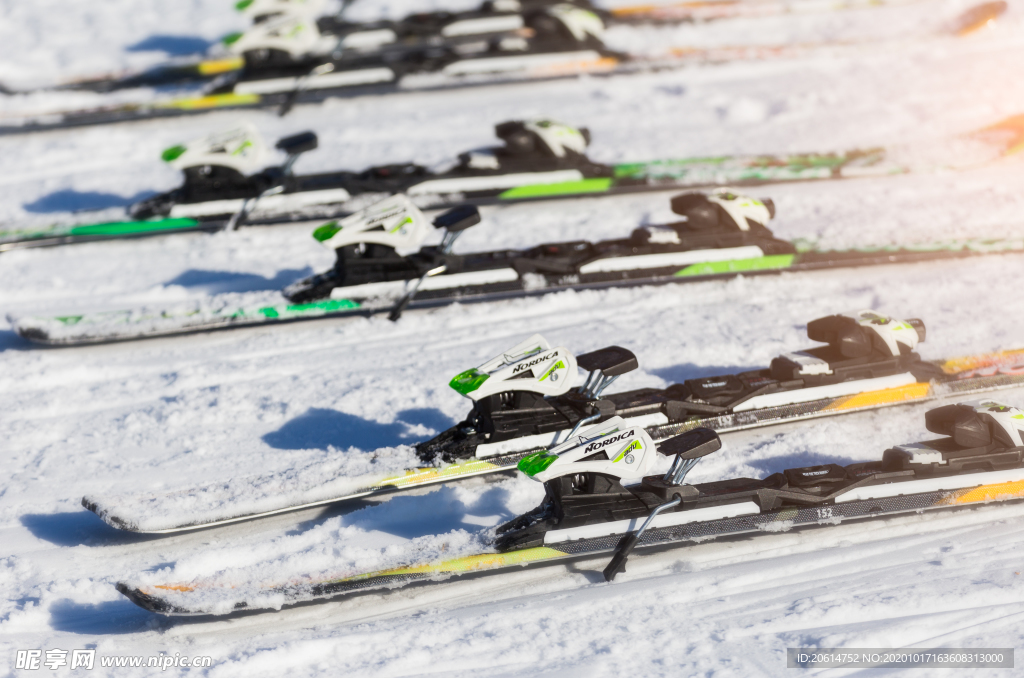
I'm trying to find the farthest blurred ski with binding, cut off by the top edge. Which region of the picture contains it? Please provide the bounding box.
[29,0,974,92]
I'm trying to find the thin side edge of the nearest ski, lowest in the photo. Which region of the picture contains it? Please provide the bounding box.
[117,477,1024,616]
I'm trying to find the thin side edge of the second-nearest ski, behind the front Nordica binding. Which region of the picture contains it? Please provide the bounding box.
[82,358,1024,535]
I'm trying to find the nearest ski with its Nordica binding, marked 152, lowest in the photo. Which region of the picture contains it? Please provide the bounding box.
[117,393,1024,615]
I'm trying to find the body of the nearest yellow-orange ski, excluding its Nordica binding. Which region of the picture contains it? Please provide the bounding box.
[117,454,1024,616]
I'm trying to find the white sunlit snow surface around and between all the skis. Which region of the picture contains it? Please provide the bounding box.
[0,0,1024,676]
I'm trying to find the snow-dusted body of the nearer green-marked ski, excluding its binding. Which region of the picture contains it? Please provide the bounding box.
[9,238,1024,346]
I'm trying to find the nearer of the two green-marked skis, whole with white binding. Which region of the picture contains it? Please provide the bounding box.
[10,183,1024,345]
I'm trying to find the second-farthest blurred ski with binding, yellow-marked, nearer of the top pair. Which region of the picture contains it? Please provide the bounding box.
[0,2,1006,134]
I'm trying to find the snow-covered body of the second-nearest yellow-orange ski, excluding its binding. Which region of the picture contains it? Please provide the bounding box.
[82,349,1024,534]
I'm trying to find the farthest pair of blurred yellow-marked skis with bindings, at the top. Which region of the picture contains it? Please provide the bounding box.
[0,0,1007,133]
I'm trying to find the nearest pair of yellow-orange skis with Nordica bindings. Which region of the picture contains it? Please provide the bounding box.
[97,311,1024,615]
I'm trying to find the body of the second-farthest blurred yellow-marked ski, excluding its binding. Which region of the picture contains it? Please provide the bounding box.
[0,2,1006,134]
